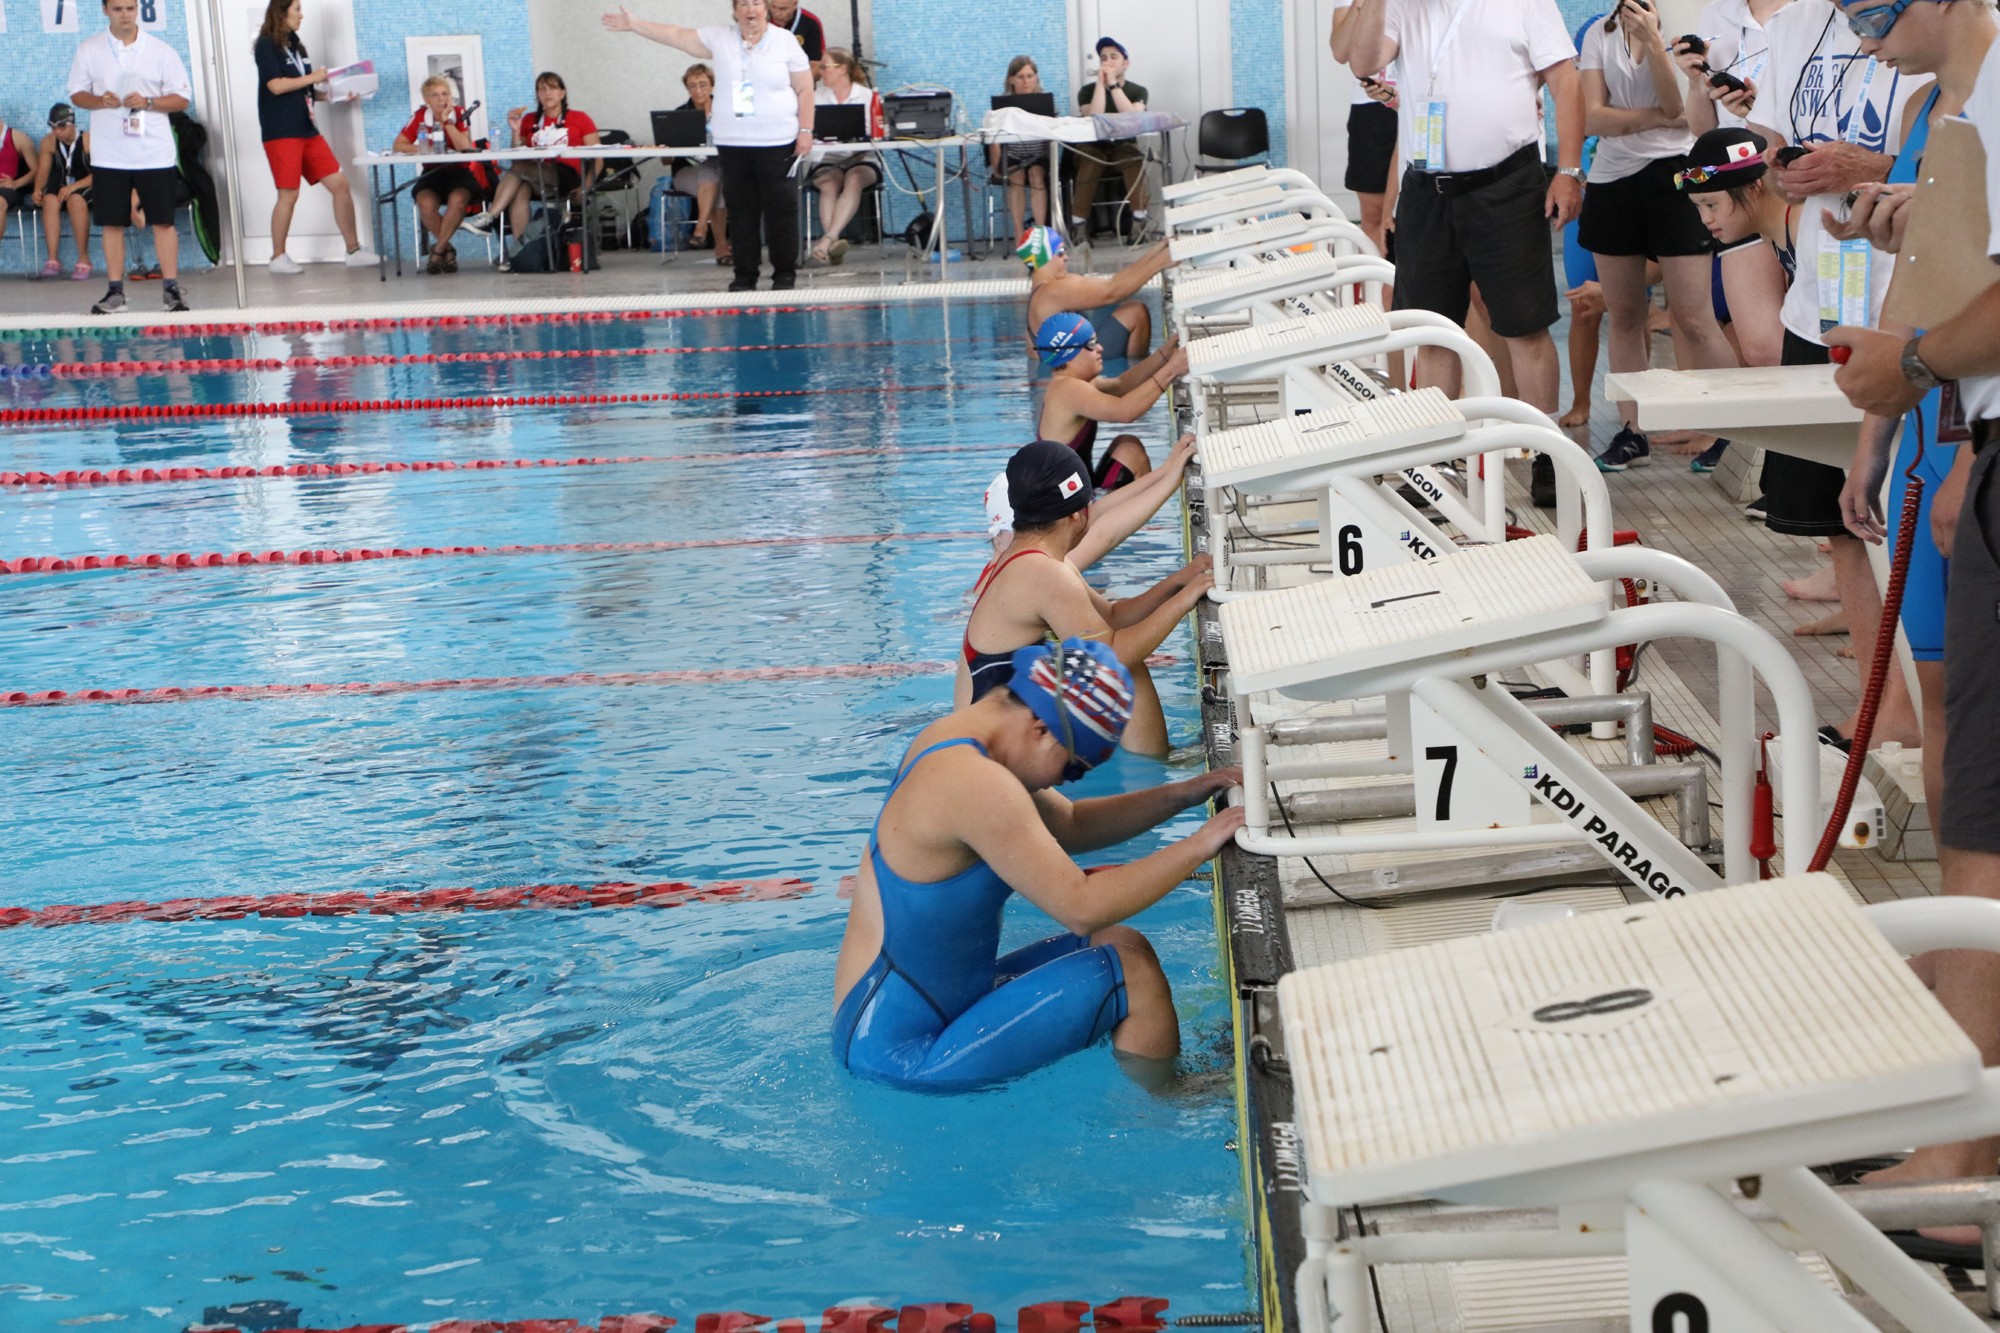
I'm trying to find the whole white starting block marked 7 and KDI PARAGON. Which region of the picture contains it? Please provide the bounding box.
[1220,536,1822,897]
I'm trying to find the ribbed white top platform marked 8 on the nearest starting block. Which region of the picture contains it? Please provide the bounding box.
[1278,875,1980,1207]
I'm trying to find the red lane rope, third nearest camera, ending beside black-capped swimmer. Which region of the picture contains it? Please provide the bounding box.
[0,662,958,709]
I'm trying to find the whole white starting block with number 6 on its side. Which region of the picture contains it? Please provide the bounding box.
[1196,388,1612,588]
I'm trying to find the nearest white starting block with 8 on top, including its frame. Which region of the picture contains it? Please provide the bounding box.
[1278,875,2000,1333]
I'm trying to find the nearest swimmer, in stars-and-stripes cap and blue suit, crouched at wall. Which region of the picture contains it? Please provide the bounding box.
[834,638,1244,1091]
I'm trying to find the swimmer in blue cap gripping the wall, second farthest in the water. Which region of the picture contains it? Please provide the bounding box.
[1034,314,1188,490]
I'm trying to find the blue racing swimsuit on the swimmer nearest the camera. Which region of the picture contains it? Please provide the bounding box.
[834,739,1126,1093]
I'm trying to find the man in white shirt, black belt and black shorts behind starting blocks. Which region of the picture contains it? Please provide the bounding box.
[1348,0,1584,416]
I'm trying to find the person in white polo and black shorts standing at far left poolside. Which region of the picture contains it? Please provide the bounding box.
[70,0,194,314]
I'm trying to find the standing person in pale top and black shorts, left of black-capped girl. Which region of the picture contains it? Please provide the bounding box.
[1576,0,1736,472]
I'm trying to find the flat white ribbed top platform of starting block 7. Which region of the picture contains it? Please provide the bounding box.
[1220,534,1610,695]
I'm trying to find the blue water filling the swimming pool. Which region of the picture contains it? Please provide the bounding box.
[0,302,1252,1333]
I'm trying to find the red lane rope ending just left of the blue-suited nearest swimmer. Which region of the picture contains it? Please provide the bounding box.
[0,879,812,931]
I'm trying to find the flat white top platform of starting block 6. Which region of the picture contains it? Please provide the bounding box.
[1196,384,1466,490]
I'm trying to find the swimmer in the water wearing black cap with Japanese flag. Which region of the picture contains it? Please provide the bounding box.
[952,440,1214,755]
